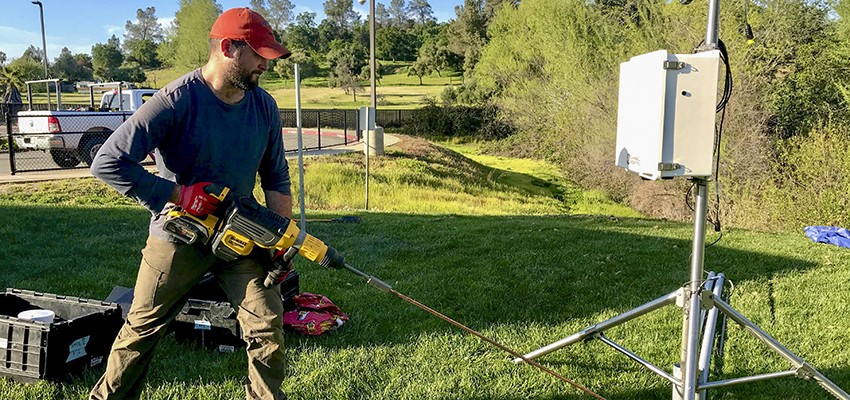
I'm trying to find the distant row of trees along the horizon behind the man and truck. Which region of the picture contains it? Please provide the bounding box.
[0,0,515,96]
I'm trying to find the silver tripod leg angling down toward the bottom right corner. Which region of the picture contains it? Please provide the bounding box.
[714,298,850,400]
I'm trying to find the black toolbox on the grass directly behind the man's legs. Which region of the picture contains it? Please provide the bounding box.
[170,270,301,353]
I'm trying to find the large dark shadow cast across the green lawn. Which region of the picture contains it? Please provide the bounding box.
[0,206,850,399]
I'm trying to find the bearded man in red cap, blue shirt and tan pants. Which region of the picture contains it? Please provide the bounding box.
[90,8,292,400]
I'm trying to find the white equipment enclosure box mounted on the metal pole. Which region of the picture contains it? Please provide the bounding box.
[617,50,720,180]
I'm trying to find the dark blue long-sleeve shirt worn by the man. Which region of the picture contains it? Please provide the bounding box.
[91,69,291,241]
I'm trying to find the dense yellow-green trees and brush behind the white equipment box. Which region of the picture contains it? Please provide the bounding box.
[458,0,850,229]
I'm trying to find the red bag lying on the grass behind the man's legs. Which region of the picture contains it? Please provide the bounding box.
[283,292,348,336]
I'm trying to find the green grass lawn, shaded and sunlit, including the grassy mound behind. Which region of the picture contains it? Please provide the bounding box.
[0,138,850,400]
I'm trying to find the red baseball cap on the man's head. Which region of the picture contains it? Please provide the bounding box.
[210,7,291,60]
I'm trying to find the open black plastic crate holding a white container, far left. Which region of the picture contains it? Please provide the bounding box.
[0,289,124,382]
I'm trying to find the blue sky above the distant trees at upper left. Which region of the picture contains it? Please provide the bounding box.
[0,0,463,62]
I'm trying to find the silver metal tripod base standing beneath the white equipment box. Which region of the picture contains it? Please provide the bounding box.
[514,178,850,400]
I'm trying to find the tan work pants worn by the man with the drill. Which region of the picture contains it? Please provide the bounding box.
[89,237,285,400]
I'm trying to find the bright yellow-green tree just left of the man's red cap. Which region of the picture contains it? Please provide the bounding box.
[173,0,221,69]
